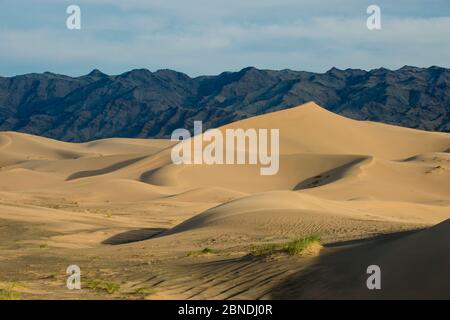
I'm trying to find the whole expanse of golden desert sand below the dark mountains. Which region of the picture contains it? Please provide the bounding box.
[0,102,450,299]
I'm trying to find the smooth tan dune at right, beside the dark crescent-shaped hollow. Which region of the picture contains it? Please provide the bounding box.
[302,158,450,204]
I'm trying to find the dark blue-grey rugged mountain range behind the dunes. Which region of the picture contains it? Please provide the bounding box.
[0,66,450,141]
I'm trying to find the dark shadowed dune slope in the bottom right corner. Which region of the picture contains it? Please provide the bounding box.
[273,219,450,299]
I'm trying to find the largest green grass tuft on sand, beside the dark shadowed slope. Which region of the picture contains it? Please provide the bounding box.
[250,235,322,257]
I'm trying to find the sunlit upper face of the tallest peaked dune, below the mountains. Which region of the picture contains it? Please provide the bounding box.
[224,102,449,160]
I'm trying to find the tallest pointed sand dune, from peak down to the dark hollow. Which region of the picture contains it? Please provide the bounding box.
[132,103,450,192]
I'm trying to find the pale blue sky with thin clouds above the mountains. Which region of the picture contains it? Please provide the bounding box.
[0,0,450,76]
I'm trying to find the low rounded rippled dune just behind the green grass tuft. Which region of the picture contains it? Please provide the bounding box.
[163,191,448,242]
